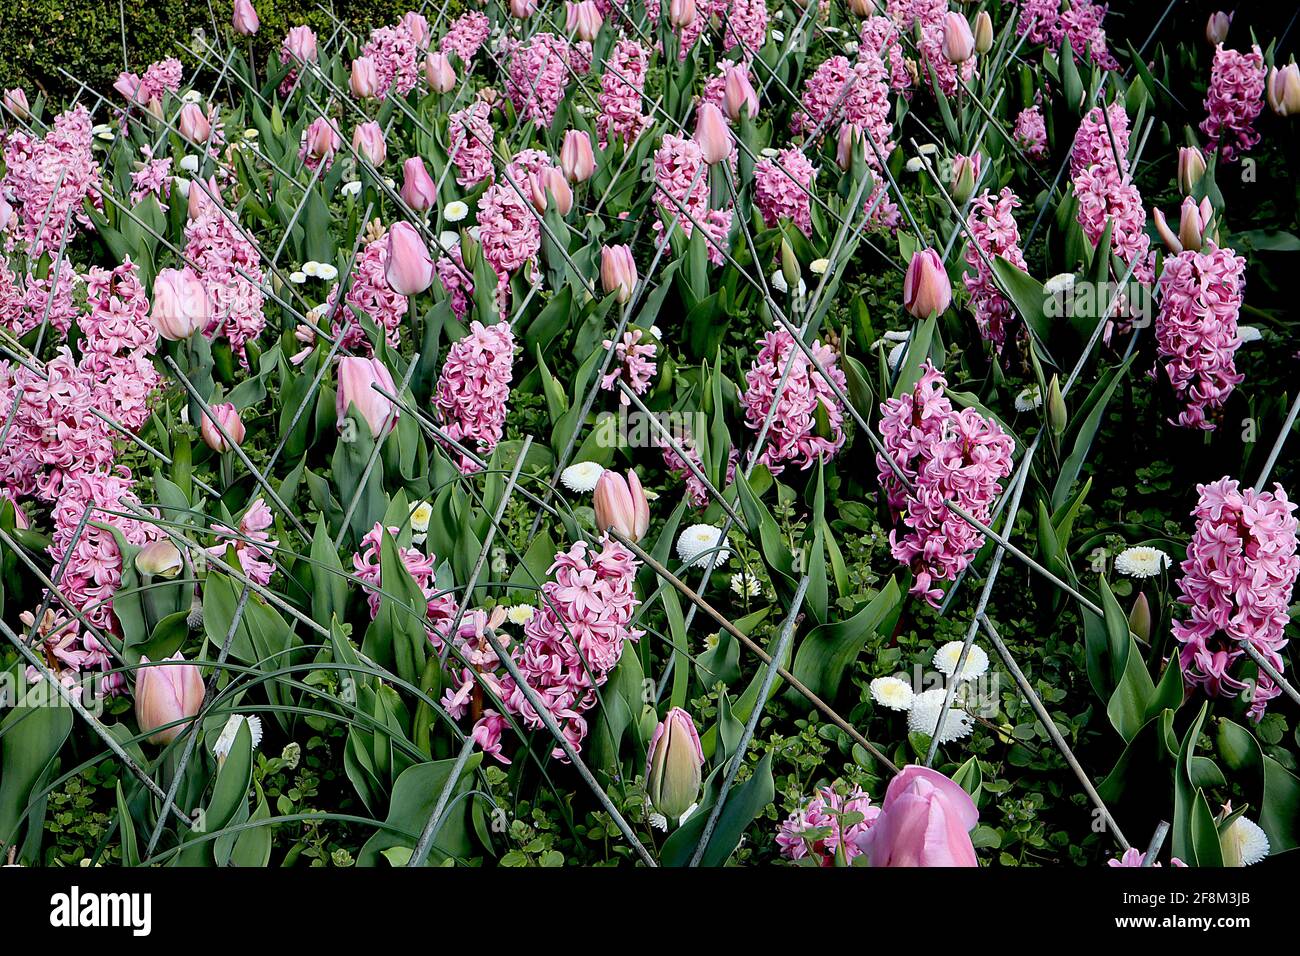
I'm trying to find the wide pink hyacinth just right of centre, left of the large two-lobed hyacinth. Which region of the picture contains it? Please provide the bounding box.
[741,329,848,475]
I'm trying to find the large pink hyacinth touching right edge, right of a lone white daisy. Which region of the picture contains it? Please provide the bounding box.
[1174,477,1300,721]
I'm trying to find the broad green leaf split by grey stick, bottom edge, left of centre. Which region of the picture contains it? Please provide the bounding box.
[356,753,482,866]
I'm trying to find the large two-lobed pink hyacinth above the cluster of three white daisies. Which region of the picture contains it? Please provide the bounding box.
[876,360,1015,607]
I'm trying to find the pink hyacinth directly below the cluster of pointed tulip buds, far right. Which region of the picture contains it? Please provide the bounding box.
[1156,242,1245,432]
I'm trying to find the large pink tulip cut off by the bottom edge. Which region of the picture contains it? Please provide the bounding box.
[866,765,979,868]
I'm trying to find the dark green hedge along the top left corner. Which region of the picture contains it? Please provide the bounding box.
[0,0,464,101]
